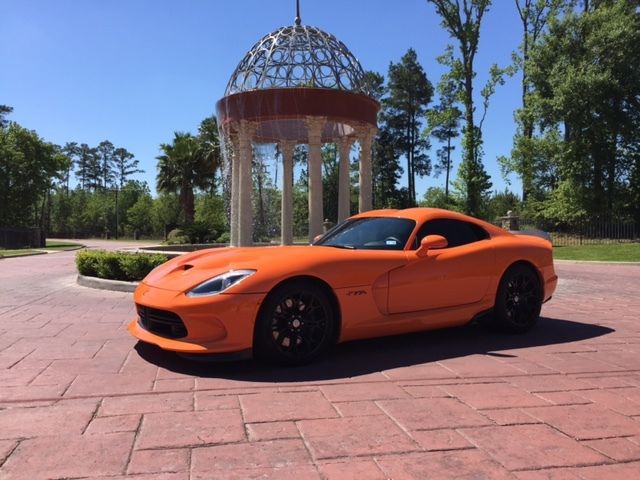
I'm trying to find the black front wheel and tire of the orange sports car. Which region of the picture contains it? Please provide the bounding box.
[253,280,336,365]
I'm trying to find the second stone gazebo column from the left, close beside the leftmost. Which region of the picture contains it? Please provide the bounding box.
[238,120,256,247]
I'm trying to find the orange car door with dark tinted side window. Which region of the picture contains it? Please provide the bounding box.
[389,219,494,313]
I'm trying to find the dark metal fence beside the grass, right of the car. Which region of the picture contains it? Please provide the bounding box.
[502,217,640,247]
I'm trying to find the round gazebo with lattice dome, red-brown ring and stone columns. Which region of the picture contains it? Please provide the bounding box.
[216,6,380,246]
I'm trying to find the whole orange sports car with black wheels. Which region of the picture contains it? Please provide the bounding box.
[129,208,558,364]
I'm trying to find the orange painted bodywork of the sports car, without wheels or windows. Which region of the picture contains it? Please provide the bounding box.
[129,208,557,353]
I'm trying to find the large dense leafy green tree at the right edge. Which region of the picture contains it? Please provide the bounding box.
[524,0,640,221]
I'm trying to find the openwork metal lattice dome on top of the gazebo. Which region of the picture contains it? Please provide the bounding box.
[225,24,368,96]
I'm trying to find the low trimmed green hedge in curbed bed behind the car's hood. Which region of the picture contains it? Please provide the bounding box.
[76,250,169,281]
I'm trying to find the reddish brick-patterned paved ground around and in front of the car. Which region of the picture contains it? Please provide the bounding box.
[0,242,640,480]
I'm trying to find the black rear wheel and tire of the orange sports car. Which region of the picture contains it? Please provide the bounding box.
[493,265,542,333]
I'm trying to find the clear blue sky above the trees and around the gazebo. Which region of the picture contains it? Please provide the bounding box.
[0,0,520,197]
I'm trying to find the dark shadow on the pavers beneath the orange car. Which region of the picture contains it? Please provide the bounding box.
[135,317,614,382]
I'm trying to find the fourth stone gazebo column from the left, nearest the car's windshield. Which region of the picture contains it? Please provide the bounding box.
[306,117,325,243]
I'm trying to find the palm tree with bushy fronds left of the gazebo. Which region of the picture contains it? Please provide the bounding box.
[156,132,215,225]
